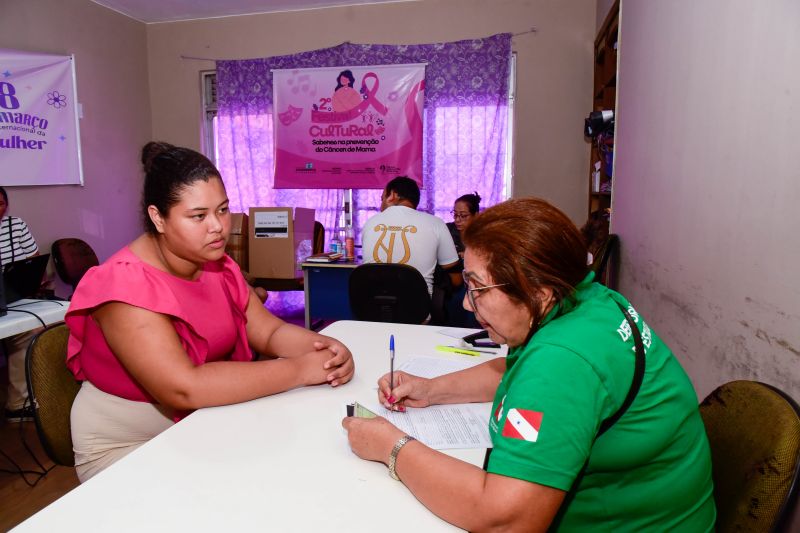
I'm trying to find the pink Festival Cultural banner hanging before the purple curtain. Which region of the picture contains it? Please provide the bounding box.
[272,64,425,189]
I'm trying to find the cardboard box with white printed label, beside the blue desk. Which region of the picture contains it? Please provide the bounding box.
[247,207,314,279]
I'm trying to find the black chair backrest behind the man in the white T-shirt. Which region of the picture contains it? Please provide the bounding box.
[350,263,431,324]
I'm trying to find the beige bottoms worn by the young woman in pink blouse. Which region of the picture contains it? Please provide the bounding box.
[71,381,174,483]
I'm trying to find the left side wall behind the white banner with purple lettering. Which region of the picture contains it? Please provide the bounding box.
[0,0,151,296]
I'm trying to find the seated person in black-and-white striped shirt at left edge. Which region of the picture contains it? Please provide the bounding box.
[0,187,39,422]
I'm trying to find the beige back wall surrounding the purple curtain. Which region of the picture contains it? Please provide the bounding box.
[142,0,595,223]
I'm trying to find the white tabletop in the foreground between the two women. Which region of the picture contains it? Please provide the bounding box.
[15,321,500,533]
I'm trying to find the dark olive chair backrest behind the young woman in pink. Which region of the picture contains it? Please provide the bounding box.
[25,322,80,466]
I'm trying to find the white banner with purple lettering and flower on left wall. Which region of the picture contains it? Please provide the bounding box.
[0,49,83,185]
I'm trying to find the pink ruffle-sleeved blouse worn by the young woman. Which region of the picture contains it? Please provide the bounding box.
[64,246,252,403]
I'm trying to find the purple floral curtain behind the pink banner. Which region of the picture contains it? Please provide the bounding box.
[216,33,511,311]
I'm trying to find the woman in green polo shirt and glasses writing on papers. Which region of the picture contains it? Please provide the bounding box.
[343,198,715,533]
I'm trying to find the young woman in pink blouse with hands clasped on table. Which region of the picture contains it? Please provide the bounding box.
[65,143,355,481]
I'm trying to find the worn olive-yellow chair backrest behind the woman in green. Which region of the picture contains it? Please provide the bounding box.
[700,381,800,532]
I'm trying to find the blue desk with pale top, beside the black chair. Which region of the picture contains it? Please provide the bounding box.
[301,261,361,329]
